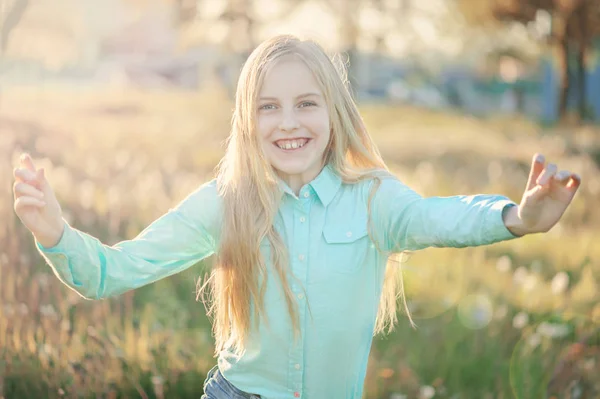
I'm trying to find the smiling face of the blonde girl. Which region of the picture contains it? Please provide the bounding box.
[257,58,330,191]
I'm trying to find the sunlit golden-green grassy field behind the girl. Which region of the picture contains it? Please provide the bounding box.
[0,86,600,399]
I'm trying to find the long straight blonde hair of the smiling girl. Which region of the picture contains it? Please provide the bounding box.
[198,35,414,354]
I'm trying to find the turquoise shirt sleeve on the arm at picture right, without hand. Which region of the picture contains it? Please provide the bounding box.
[371,178,517,252]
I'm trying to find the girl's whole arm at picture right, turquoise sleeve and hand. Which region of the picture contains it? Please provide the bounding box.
[371,154,581,252]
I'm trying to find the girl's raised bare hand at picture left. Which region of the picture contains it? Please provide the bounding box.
[13,154,64,248]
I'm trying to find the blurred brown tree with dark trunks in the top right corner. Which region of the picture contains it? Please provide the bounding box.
[457,0,600,122]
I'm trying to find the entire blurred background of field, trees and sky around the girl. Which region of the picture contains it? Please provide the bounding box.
[0,0,600,399]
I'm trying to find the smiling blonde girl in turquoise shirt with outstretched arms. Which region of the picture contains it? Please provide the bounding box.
[14,36,580,399]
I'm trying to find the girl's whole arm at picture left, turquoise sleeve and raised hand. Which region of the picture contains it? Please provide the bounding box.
[13,154,221,299]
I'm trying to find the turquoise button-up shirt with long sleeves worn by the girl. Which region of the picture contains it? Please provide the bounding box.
[36,166,515,399]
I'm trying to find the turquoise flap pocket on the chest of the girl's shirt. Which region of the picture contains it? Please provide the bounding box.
[323,217,371,273]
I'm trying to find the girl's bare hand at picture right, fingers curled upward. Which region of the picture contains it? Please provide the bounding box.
[518,154,581,234]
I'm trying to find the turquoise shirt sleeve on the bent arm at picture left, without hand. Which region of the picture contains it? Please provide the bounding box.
[35,180,220,299]
